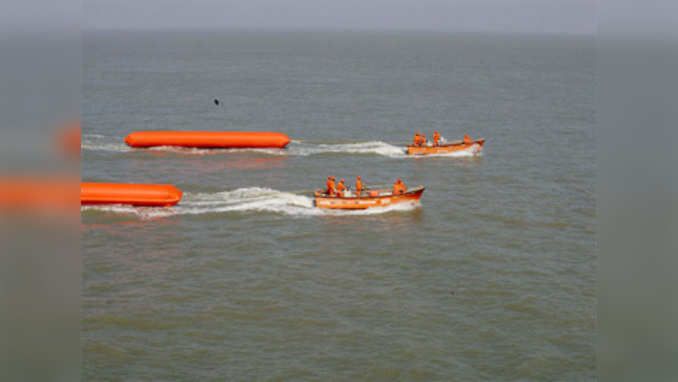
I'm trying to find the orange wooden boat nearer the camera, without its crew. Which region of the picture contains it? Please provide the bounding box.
[315,186,424,210]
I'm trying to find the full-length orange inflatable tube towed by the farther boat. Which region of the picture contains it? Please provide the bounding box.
[125,131,290,148]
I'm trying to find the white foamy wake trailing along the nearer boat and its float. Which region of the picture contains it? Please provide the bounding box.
[81,187,419,219]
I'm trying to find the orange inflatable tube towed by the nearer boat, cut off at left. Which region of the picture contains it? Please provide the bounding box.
[80,183,182,207]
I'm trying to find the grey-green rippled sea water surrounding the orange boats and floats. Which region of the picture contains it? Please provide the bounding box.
[82,31,597,381]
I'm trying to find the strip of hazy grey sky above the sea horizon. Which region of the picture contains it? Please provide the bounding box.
[83,0,596,34]
